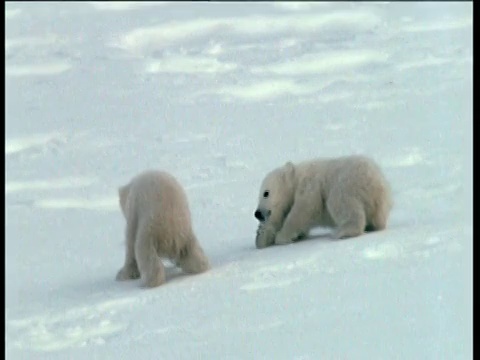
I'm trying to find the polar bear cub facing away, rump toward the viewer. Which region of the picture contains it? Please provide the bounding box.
[116,170,210,287]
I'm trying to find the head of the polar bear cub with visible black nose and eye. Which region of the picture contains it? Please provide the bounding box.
[254,162,295,223]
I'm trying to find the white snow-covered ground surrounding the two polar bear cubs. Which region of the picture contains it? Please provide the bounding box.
[5,2,473,360]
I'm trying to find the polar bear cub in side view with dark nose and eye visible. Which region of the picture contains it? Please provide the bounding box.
[254,155,393,249]
